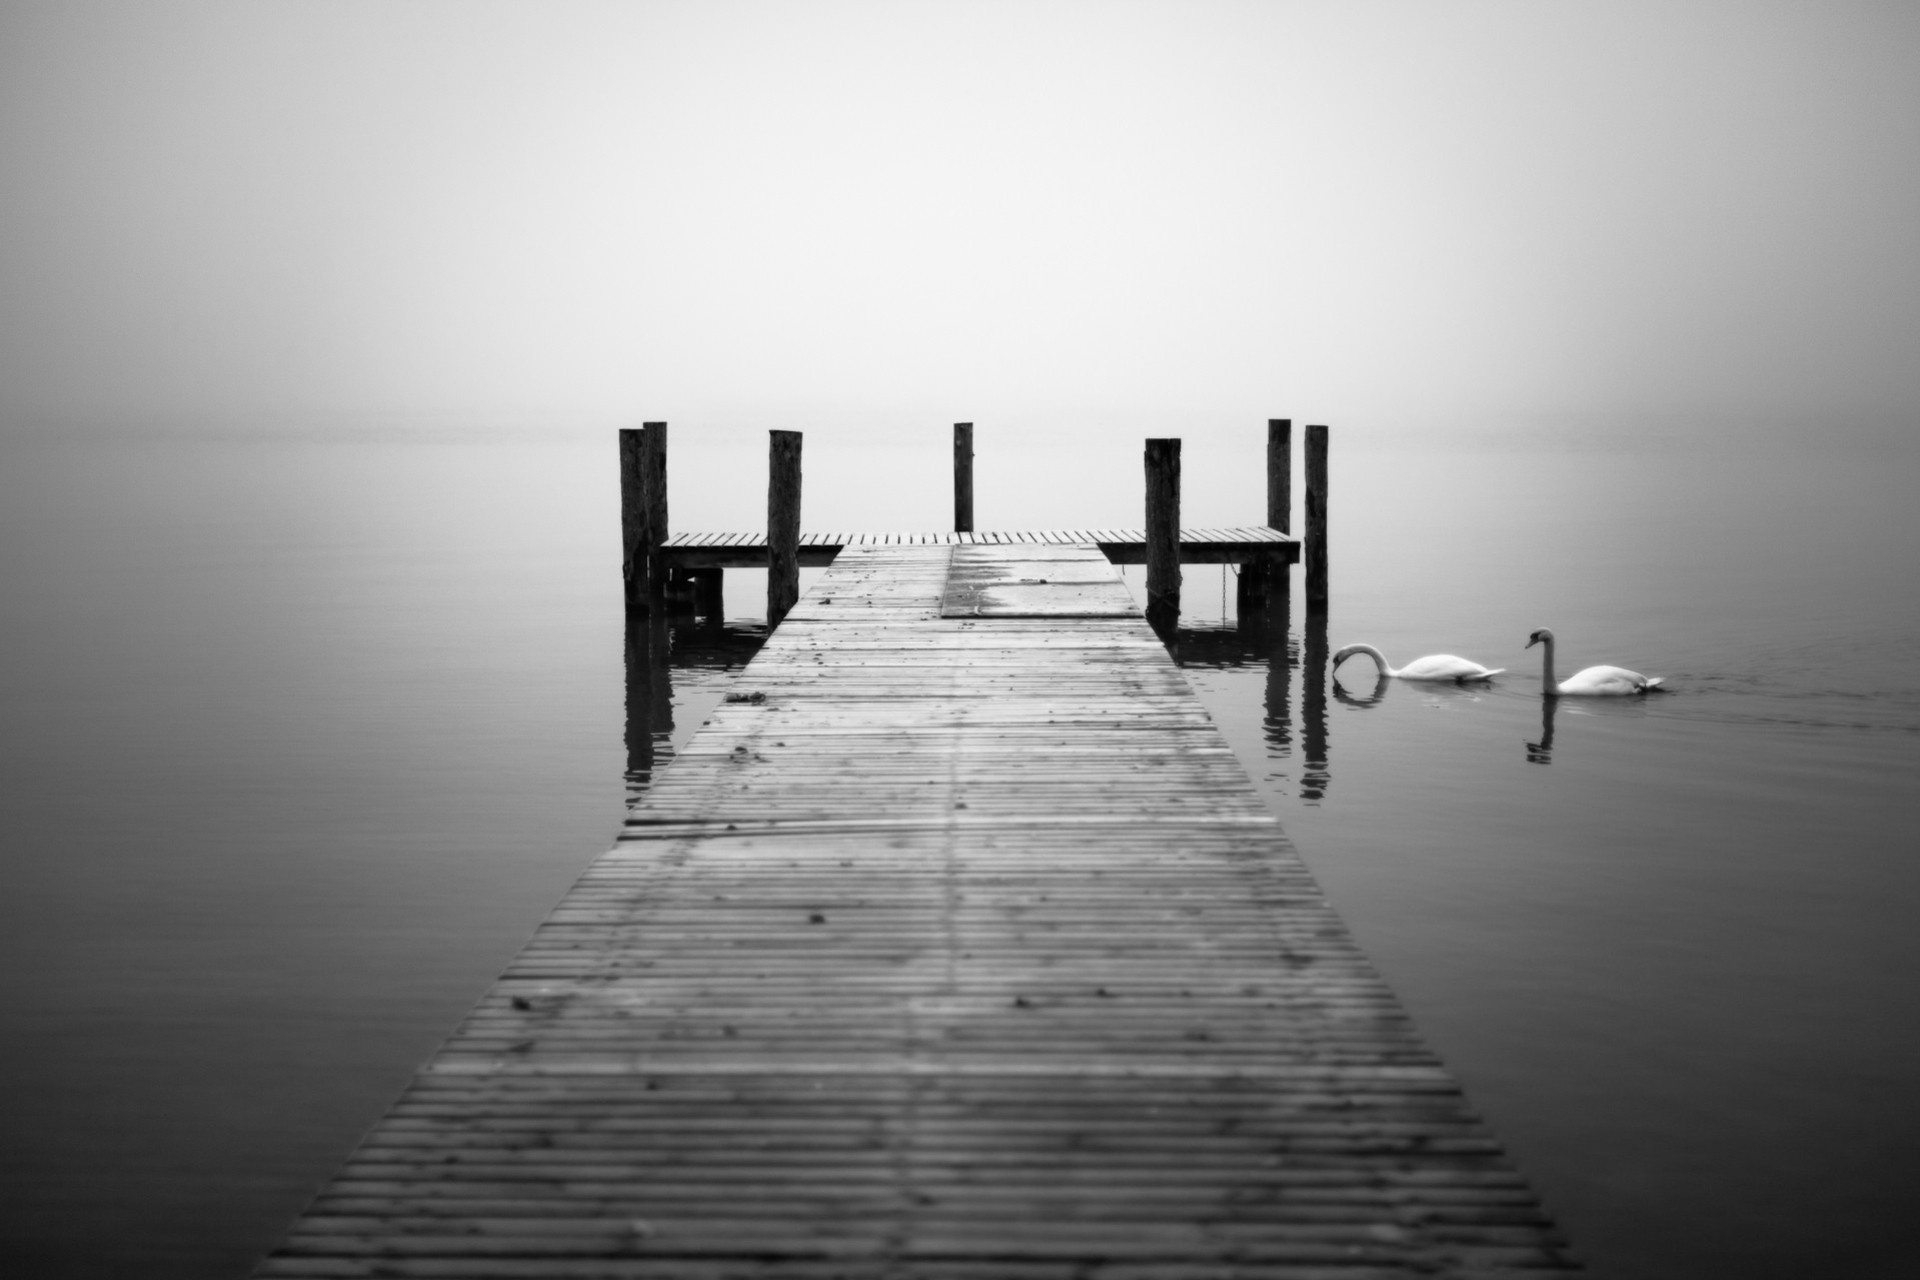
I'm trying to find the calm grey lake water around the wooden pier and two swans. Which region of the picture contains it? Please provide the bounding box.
[0,424,1920,1280]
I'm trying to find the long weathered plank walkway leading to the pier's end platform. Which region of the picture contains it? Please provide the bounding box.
[259,543,1572,1280]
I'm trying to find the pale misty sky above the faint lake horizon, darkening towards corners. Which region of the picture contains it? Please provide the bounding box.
[0,0,1920,428]
